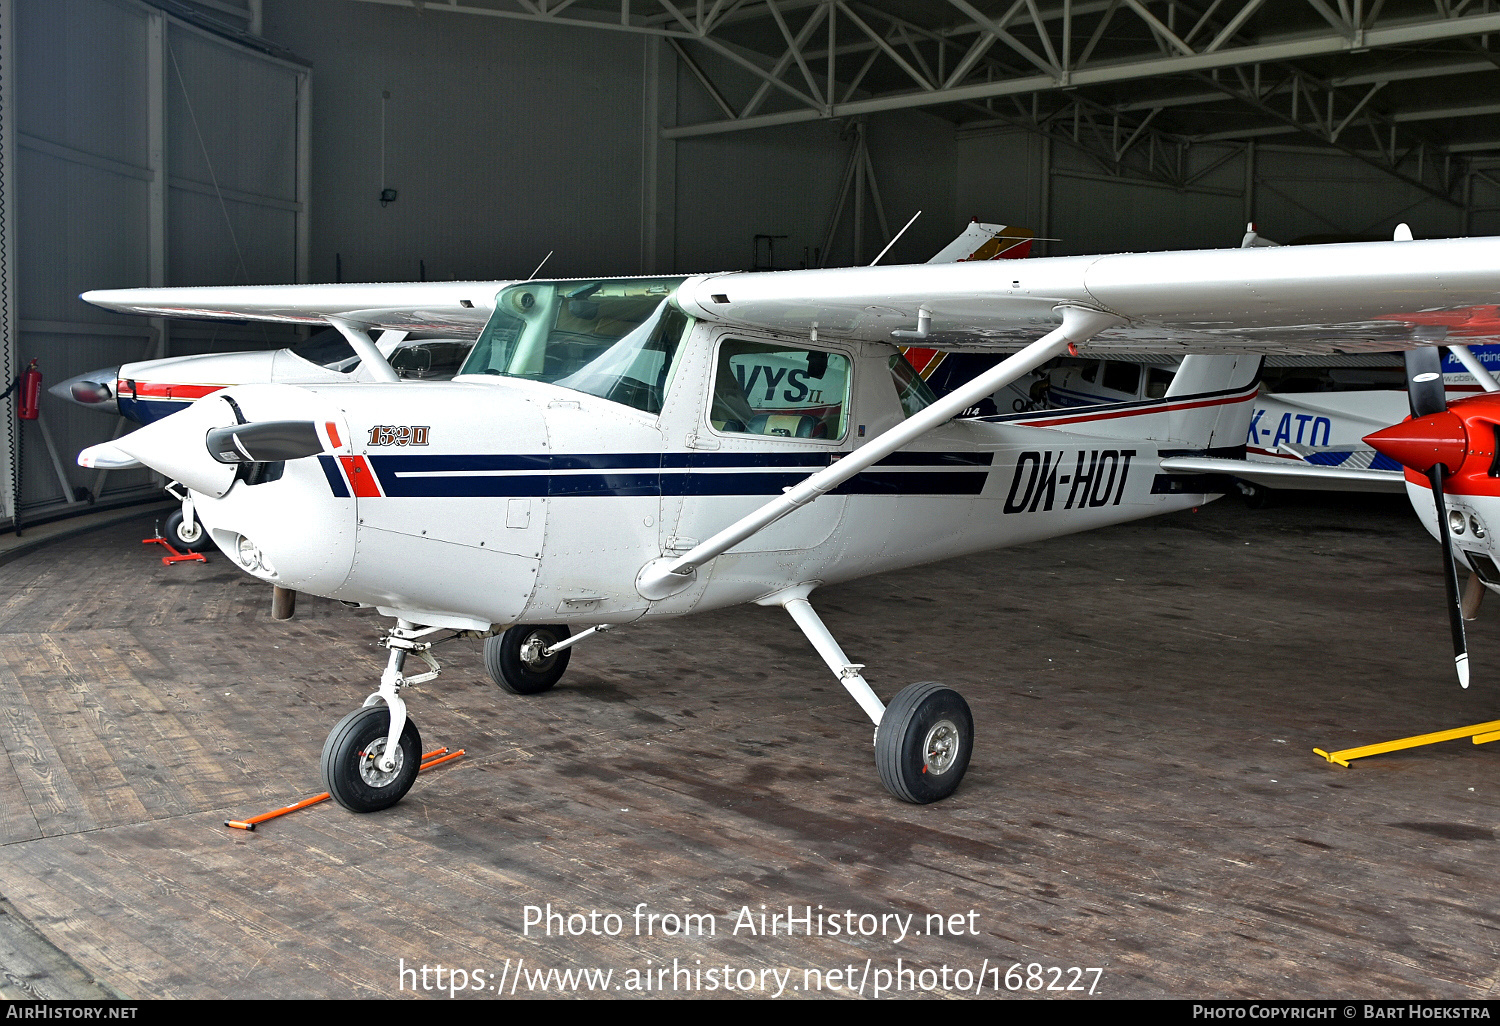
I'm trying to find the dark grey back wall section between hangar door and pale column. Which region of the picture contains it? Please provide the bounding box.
[266,2,644,282]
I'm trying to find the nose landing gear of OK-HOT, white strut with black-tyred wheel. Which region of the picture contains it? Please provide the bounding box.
[323,620,443,812]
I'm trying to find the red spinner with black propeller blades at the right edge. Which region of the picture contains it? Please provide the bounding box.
[1365,347,1478,687]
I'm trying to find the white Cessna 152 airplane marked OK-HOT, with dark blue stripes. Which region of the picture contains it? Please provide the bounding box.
[80,231,1500,812]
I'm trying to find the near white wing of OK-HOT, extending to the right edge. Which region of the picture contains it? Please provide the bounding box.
[678,239,1500,354]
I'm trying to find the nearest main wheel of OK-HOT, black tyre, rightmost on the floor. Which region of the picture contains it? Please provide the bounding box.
[875,681,974,806]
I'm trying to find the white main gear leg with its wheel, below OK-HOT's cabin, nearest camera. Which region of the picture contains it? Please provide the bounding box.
[759,585,974,806]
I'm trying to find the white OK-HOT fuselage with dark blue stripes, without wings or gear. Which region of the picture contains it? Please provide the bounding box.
[187,324,1254,629]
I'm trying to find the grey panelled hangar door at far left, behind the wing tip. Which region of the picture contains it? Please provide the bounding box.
[8,0,306,518]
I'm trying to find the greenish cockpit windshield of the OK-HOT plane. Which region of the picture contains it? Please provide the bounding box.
[462,278,693,414]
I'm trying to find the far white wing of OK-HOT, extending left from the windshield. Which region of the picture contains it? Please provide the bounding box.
[83,282,515,338]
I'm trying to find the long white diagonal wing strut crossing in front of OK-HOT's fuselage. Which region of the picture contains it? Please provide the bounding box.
[636,306,1125,602]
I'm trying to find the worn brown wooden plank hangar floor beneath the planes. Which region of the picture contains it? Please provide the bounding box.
[0,498,1500,999]
